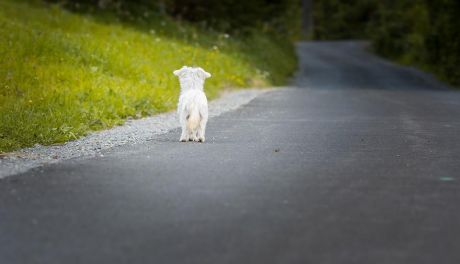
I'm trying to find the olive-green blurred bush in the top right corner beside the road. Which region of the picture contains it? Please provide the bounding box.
[368,0,460,85]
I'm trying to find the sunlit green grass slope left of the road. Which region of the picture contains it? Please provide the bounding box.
[0,0,296,152]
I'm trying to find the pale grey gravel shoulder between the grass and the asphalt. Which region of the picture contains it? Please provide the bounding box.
[0,89,270,179]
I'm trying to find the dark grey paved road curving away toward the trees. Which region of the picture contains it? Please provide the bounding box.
[0,42,460,264]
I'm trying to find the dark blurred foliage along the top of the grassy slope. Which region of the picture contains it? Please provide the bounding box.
[49,0,300,40]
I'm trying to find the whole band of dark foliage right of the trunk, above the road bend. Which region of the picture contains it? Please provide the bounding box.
[314,0,460,85]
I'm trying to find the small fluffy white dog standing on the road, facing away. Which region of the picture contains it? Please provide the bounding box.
[174,66,211,142]
